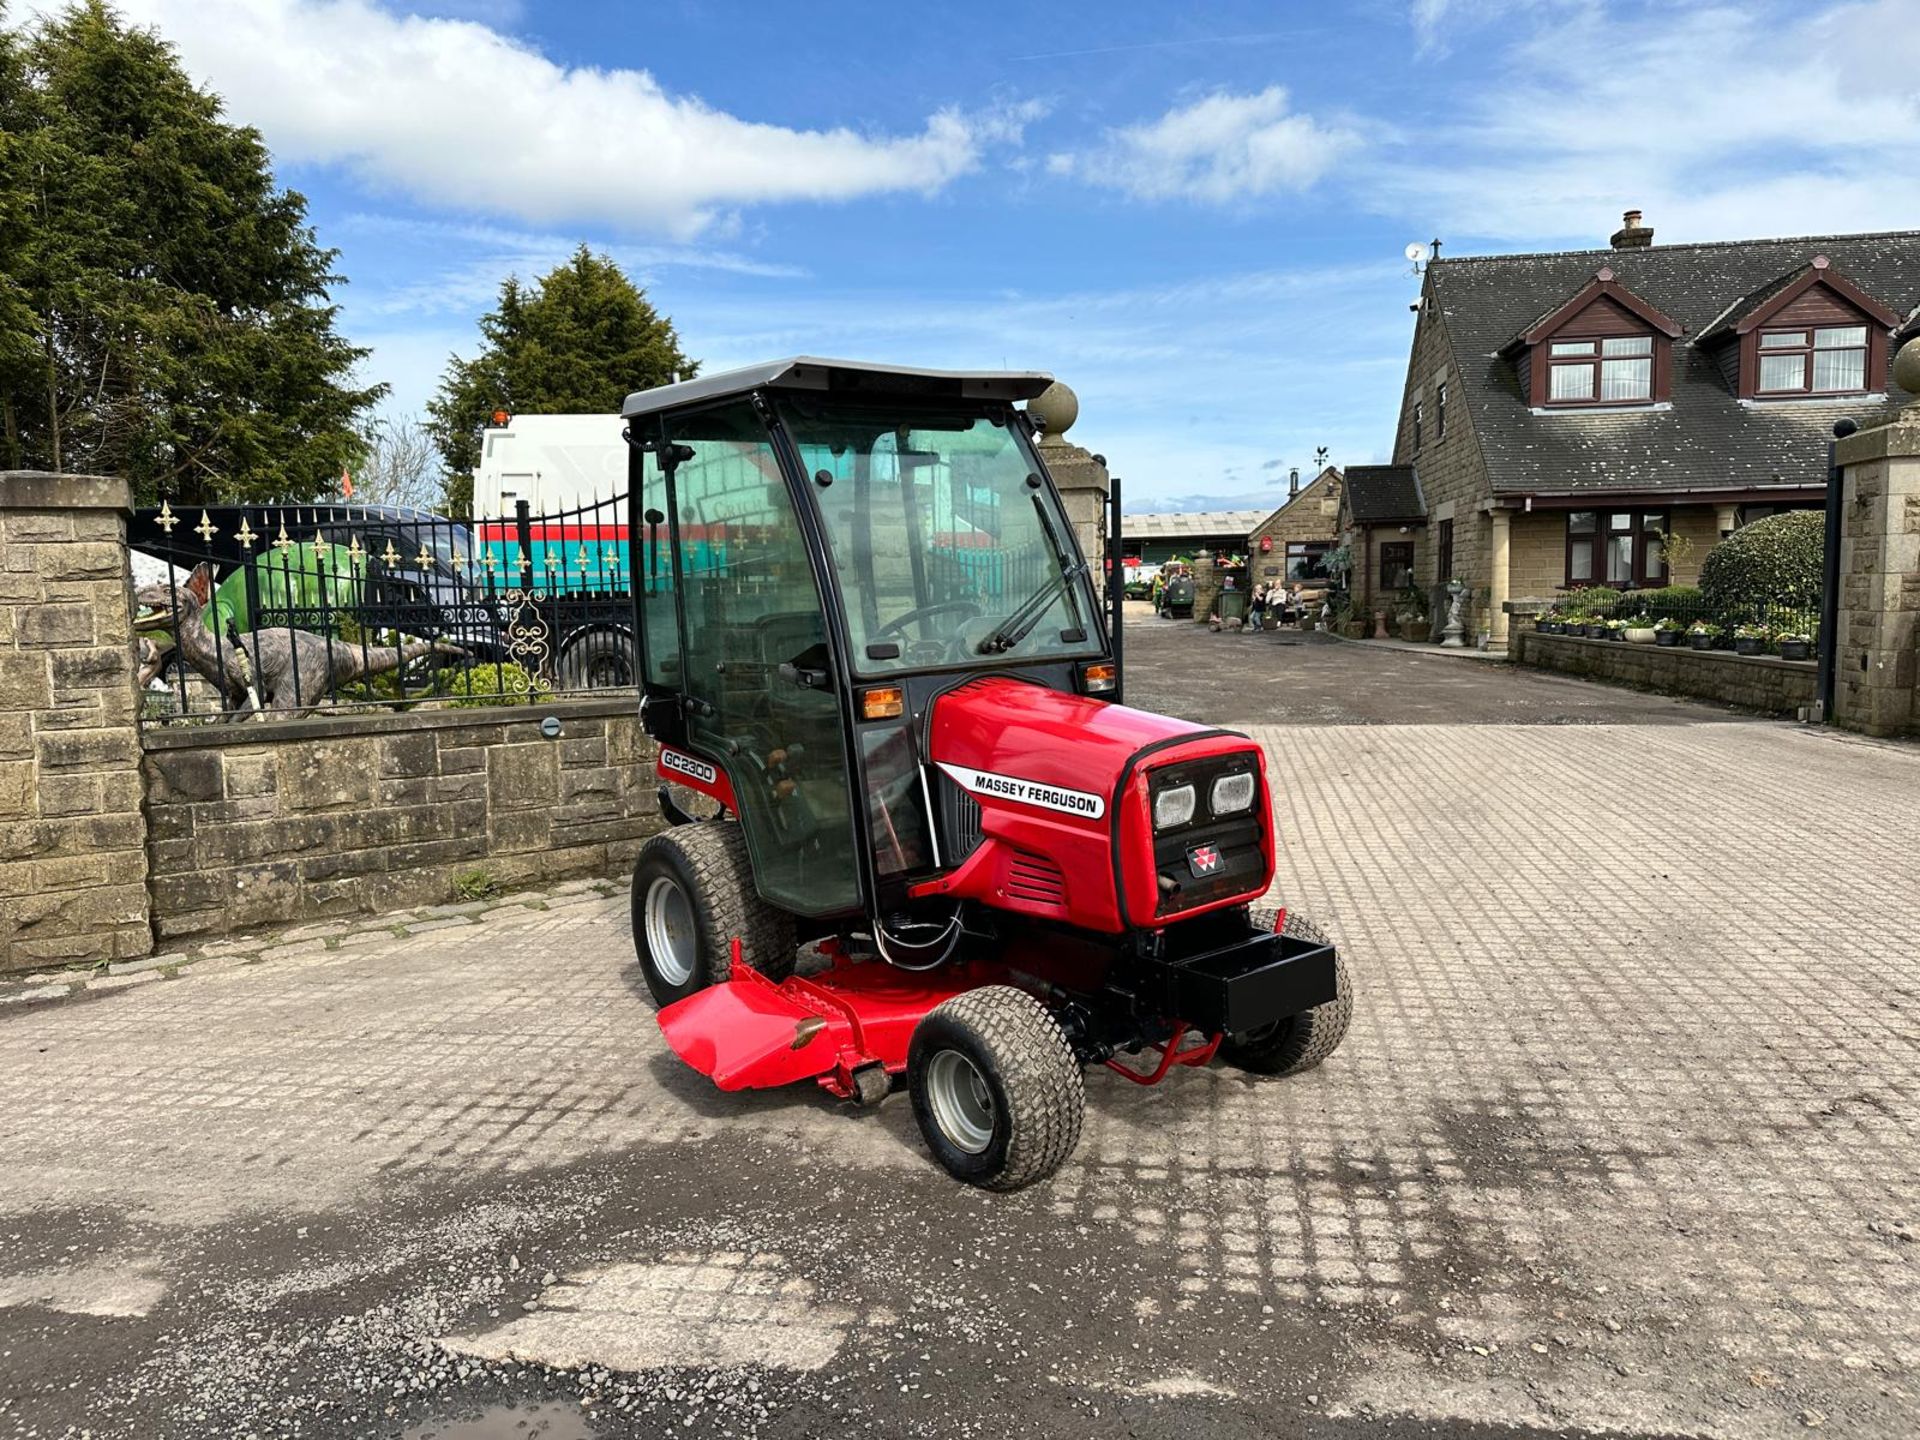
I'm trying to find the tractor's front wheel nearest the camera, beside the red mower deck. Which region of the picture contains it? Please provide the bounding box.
[906,985,1087,1190]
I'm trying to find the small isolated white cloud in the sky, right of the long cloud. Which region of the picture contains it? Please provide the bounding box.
[1048,84,1359,204]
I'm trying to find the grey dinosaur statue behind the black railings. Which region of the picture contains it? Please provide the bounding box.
[132,564,467,720]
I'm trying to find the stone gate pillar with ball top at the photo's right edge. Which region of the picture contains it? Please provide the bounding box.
[1834,340,1920,735]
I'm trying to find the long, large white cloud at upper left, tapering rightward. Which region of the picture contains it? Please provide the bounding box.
[67,0,1037,238]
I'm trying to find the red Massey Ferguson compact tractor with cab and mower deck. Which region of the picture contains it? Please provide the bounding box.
[622,359,1352,1190]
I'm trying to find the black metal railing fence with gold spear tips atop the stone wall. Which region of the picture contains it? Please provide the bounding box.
[129,495,637,722]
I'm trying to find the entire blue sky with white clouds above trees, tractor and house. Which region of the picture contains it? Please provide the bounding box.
[29,0,1920,509]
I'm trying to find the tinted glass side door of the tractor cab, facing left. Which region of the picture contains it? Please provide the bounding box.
[668,401,860,916]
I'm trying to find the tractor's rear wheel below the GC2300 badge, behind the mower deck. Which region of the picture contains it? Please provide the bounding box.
[634,820,793,1006]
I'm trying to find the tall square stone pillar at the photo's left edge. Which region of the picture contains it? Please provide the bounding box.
[0,480,154,972]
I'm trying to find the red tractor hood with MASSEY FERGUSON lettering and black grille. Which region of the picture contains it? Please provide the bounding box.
[914,676,1273,933]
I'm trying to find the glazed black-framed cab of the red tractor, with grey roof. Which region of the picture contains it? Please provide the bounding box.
[624,361,1114,918]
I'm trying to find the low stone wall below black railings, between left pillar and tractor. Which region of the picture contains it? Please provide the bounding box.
[144,695,660,939]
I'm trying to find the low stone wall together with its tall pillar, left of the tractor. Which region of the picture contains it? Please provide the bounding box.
[0,472,660,973]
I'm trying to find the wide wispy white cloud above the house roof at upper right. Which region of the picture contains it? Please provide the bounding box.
[1361,0,1920,246]
